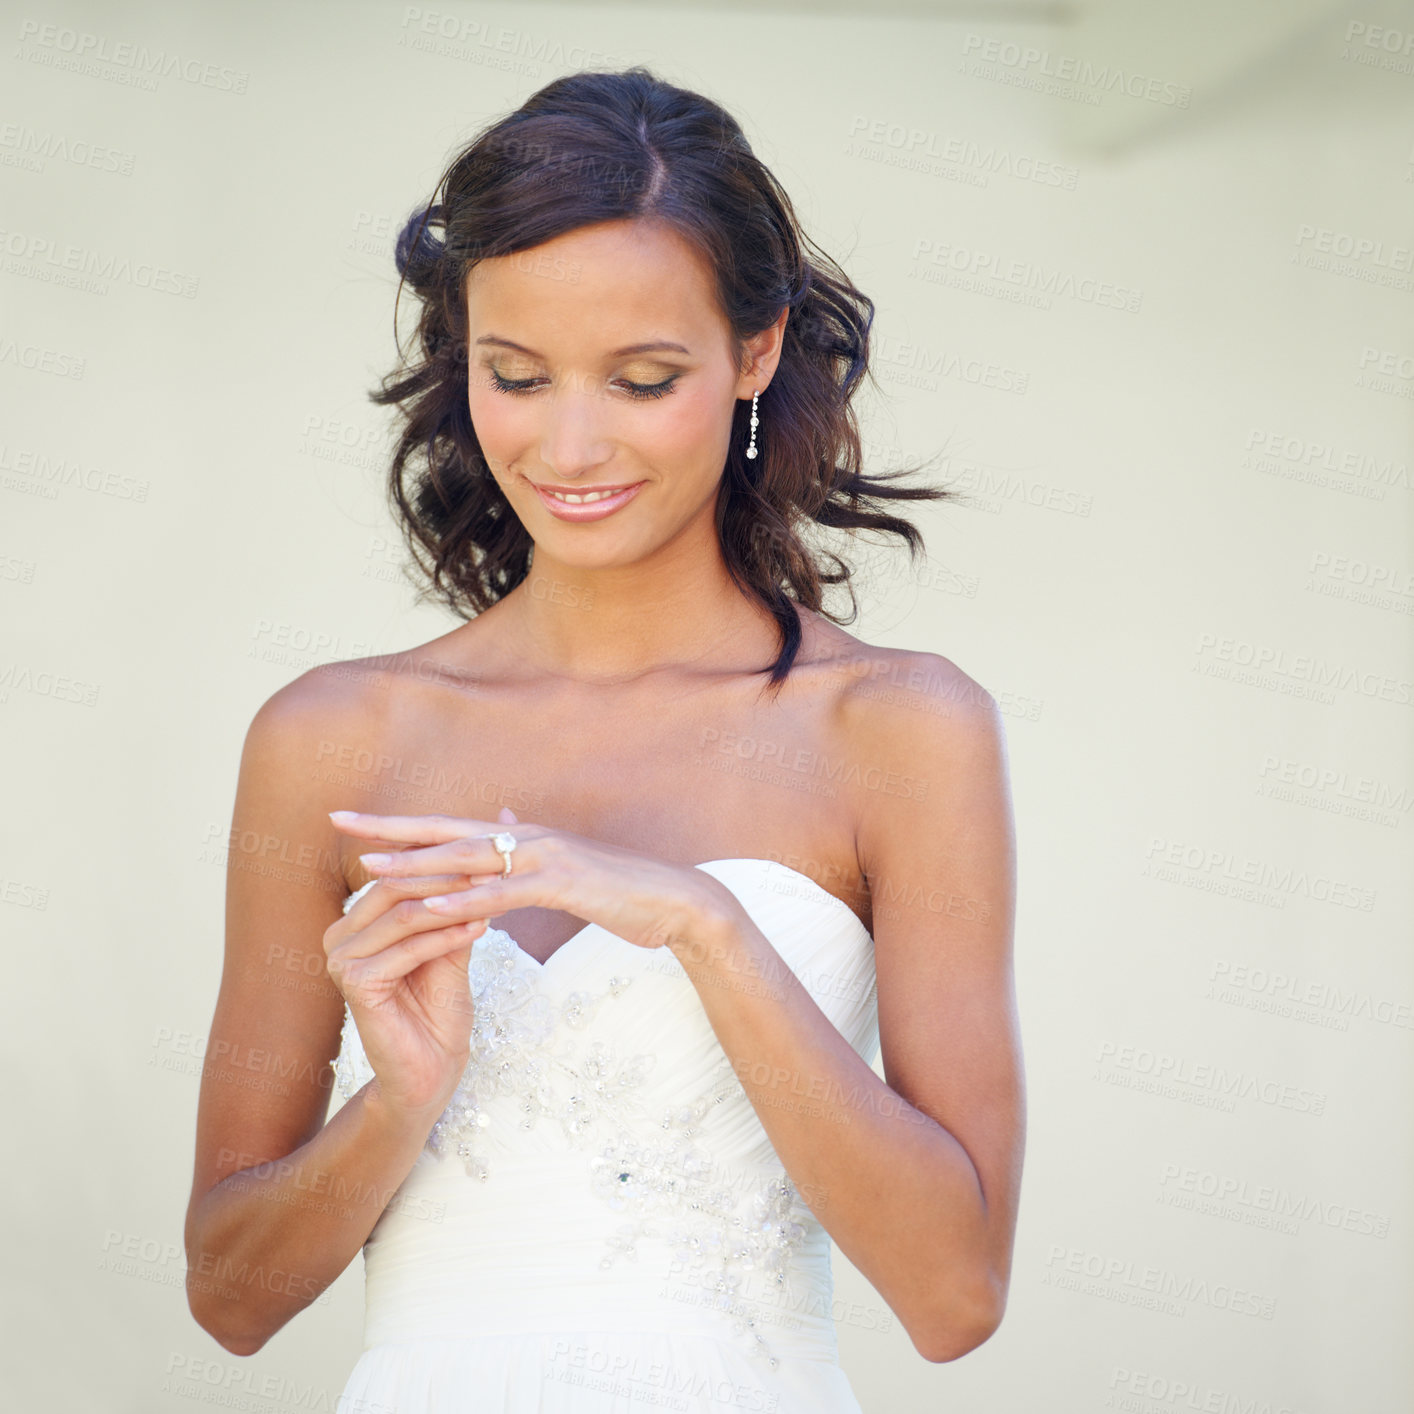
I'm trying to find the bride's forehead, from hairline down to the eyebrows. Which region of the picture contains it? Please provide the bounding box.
[467,221,727,349]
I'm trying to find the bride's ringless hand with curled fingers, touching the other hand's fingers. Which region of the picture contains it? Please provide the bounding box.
[324,874,486,1116]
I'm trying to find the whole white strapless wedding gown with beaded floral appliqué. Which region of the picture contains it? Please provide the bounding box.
[334,858,878,1414]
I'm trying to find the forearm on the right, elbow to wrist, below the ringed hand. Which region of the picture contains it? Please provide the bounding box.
[673,913,994,1359]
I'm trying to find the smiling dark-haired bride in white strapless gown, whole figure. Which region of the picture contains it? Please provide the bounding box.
[187,68,1024,1414]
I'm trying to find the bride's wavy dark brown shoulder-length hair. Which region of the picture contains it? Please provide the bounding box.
[369,66,956,689]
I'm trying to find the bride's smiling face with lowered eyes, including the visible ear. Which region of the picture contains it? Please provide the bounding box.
[467,221,783,567]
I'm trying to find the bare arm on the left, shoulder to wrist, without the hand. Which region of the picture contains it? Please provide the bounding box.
[185,672,445,1355]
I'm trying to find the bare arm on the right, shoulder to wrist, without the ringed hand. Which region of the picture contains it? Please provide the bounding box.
[677,655,1025,1362]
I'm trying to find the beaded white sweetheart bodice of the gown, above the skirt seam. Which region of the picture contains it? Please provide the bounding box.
[334,858,878,1365]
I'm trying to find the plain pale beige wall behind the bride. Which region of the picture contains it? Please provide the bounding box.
[0,0,1414,1414]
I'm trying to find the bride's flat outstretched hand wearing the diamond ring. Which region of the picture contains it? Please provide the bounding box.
[329,809,742,947]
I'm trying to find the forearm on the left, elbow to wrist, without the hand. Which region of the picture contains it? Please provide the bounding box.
[187,1080,437,1355]
